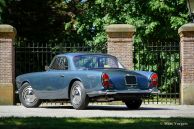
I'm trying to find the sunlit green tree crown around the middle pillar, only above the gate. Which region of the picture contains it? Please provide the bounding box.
[75,0,188,49]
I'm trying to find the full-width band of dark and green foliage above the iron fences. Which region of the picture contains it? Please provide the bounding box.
[0,0,188,46]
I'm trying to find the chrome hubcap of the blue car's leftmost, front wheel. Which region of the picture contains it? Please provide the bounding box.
[22,86,37,103]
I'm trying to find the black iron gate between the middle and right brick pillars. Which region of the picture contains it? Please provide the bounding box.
[134,40,180,104]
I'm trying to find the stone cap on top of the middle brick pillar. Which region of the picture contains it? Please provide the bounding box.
[105,24,136,32]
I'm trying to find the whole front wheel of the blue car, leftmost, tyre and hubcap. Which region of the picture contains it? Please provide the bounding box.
[19,83,41,108]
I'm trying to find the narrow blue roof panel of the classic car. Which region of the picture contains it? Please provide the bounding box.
[57,53,112,57]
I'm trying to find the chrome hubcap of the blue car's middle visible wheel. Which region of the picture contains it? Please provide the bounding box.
[71,86,81,105]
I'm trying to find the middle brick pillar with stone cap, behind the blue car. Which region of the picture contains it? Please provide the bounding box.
[106,24,136,69]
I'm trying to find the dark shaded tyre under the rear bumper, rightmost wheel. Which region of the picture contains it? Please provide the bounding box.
[124,98,142,110]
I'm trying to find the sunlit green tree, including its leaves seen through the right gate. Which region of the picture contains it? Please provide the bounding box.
[71,0,188,92]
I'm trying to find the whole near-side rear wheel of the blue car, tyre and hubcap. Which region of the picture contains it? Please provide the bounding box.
[70,81,89,110]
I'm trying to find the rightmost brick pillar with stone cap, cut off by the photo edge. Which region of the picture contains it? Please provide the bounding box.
[178,23,194,105]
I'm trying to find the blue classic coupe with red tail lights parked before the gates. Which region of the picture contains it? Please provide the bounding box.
[16,53,158,109]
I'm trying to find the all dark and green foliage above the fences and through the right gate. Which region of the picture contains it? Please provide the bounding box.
[0,0,188,92]
